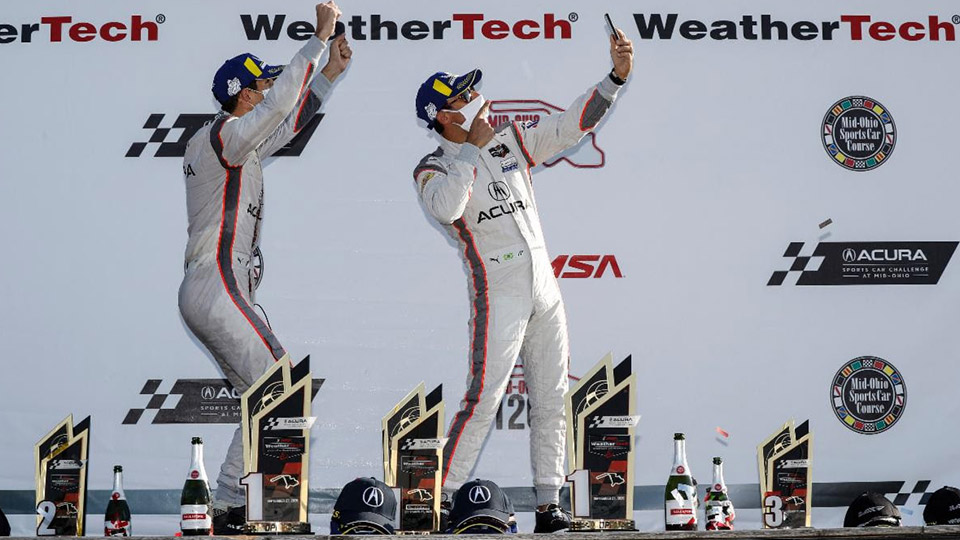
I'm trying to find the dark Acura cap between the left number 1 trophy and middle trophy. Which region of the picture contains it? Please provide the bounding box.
[330,478,397,534]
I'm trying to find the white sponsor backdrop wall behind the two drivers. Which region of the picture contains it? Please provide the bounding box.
[0,0,960,533]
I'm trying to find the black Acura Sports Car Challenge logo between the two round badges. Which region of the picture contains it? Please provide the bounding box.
[767,242,957,286]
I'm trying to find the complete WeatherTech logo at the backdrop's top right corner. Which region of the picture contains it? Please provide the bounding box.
[633,13,960,41]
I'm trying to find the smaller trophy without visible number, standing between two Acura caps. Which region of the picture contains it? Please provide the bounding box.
[381,383,446,534]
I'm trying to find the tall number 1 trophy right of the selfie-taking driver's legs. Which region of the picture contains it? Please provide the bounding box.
[564,354,640,531]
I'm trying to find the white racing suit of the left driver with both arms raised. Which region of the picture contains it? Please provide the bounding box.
[179,37,330,506]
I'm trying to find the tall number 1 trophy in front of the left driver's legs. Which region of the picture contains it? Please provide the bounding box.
[240,356,316,534]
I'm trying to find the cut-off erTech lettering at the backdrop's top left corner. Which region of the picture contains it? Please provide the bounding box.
[0,14,167,43]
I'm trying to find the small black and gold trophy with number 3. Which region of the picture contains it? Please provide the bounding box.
[757,420,813,529]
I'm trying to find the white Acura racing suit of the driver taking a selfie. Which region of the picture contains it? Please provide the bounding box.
[413,77,619,504]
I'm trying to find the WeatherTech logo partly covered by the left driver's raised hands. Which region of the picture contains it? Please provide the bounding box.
[240,13,580,41]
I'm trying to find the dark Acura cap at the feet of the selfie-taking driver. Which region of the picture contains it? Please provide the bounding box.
[450,478,513,534]
